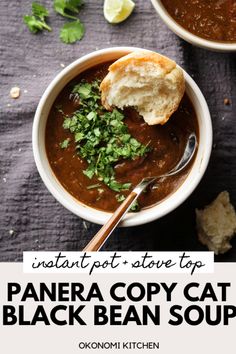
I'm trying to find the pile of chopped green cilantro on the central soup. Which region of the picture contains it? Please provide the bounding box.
[60,81,150,192]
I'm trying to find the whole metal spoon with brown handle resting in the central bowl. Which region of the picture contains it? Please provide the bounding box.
[83,133,197,252]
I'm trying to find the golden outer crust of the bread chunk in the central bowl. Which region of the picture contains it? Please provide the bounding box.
[100,50,185,125]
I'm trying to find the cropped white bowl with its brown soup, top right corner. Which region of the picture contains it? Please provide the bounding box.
[151,0,236,52]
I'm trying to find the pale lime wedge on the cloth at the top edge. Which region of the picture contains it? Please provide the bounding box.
[103,0,135,23]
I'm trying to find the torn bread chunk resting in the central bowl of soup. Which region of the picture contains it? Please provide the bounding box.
[100,50,185,125]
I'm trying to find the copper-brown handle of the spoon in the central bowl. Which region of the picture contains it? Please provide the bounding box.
[83,191,138,252]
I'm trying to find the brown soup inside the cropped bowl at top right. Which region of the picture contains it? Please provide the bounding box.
[161,0,236,43]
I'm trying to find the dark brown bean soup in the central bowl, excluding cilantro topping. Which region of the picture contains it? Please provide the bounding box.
[46,63,198,212]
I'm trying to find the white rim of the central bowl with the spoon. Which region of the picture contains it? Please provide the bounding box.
[32,47,212,227]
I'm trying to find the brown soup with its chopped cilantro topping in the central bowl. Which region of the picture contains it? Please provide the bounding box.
[45,63,198,211]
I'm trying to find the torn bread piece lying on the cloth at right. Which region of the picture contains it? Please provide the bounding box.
[196,191,236,254]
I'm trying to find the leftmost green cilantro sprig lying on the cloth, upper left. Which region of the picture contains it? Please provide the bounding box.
[23,2,52,33]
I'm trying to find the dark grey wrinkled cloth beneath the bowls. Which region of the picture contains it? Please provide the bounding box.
[0,0,236,261]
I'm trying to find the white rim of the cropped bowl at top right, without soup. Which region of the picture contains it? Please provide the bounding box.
[151,0,236,52]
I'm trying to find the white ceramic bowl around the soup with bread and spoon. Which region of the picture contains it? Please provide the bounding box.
[33,47,212,226]
